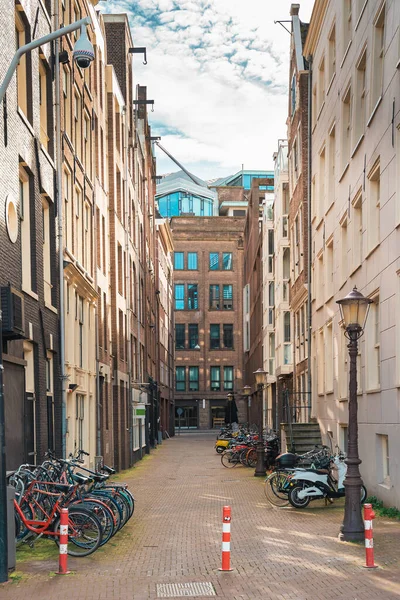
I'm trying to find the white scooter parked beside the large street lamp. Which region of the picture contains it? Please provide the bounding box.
[288,452,367,508]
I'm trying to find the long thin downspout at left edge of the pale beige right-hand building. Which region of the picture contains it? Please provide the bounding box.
[307,56,313,420]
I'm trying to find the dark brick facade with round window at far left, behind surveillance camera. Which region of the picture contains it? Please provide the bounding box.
[0,0,61,469]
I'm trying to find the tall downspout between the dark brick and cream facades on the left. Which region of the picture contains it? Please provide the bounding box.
[54,1,67,458]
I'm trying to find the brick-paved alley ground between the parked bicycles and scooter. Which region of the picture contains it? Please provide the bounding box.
[0,433,400,600]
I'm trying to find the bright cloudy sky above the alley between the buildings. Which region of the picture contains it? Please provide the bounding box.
[99,0,314,179]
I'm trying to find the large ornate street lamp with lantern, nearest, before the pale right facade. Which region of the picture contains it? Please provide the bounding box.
[337,287,372,542]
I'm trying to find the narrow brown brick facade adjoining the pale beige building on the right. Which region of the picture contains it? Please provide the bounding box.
[288,4,311,422]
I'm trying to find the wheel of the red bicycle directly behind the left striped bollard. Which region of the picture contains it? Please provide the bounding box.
[54,506,101,557]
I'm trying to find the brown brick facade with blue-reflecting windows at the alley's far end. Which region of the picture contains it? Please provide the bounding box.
[171,217,247,429]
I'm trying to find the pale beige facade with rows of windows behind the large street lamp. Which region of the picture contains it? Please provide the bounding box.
[304,0,400,506]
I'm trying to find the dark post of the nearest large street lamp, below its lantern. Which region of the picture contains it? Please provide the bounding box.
[340,328,364,542]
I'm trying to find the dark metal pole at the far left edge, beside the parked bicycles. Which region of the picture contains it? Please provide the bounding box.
[0,310,8,583]
